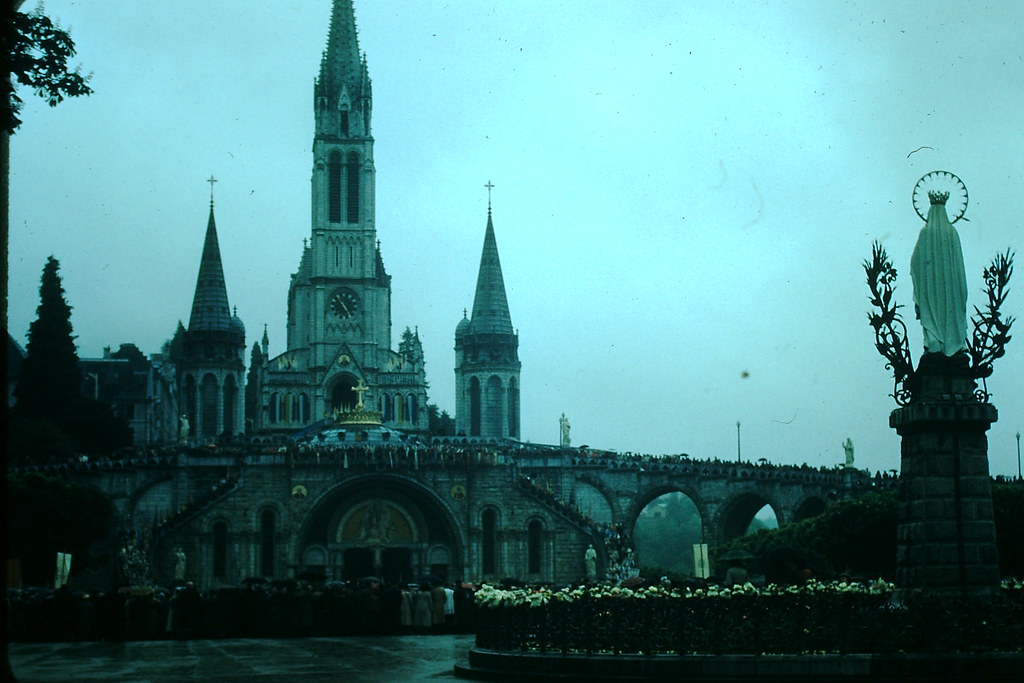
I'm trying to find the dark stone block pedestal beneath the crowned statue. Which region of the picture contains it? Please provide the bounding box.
[889,353,999,598]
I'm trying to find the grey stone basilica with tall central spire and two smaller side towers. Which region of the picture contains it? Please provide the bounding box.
[168,0,520,442]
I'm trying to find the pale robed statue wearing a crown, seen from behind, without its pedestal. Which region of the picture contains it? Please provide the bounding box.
[910,188,967,356]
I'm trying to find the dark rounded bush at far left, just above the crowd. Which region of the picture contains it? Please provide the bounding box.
[5,472,114,586]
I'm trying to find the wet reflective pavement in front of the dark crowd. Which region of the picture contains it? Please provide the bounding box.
[7,635,474,683]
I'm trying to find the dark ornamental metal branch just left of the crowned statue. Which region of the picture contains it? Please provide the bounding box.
[864,242,913,405]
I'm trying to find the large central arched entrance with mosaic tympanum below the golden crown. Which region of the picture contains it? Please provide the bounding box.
[299,475,463,585]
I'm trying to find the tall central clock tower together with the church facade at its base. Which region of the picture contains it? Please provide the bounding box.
[256,0,427,431]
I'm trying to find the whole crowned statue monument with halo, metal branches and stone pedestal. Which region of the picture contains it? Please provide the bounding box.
[864,171,1014,597]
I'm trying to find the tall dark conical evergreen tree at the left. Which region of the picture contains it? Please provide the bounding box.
[14,256,82,425]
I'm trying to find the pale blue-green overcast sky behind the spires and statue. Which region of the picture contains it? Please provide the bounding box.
[9,0,1024,475]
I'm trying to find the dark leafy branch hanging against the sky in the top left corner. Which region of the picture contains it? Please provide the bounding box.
[0,3,92,133]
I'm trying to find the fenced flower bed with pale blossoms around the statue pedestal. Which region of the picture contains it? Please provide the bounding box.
[476,581,1024,655]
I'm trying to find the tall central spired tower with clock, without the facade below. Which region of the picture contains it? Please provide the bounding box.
[288,0,391,378]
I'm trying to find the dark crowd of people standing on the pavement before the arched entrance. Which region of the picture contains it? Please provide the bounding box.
[7,579,475,641]
